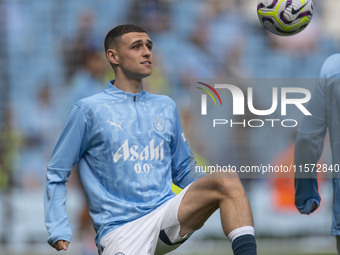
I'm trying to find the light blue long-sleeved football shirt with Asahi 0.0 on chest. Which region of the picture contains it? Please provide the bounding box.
[45,81,202,247]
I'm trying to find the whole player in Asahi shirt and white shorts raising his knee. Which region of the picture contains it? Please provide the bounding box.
[45,25,256,255]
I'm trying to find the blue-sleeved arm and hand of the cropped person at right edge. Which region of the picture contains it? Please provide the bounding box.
[294,73,327,214]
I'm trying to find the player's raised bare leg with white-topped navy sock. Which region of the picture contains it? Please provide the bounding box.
[178,176,256,255]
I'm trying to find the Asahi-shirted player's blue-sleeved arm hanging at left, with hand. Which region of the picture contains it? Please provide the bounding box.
[44,105,88,250]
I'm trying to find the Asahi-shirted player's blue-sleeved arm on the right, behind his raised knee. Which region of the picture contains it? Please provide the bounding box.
[171,104,205,188]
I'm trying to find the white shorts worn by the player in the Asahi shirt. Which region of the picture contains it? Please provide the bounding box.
[100,185,191,255]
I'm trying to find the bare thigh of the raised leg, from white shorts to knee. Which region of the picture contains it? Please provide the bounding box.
[178,175,244,235]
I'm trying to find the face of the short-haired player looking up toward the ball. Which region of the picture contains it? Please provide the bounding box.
[117,32,152,79]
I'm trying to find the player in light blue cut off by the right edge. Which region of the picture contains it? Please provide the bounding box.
[294,54,340,255]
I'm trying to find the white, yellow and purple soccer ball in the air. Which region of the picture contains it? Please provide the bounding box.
[257,0,314,36]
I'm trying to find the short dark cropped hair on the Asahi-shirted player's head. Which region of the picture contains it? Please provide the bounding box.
[104,24,146,52]
